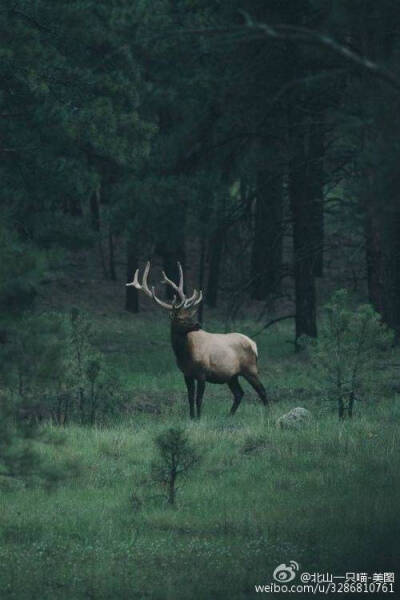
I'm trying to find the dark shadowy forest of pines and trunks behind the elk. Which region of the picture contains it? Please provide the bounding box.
[0,0,400,338]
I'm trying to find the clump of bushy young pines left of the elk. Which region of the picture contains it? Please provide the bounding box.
[0,310,121,424]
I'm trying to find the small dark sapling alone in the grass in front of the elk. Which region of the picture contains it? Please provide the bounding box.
[151,427,199,504]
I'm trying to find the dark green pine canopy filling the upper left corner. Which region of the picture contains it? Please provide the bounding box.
[0,0,155,262]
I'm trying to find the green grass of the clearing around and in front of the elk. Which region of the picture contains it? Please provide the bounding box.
[0,317,400,600]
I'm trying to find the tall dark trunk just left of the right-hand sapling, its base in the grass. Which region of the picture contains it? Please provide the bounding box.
[289,105,317,340]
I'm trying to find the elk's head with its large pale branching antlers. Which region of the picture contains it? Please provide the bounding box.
[126,261,203,332]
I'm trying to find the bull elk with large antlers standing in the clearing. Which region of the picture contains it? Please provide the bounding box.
[126,262,268,419]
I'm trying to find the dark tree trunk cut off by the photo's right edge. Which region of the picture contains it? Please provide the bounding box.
[355,8,400,341]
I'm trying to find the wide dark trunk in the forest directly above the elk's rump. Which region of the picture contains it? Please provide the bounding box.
[251,166,283,300]
